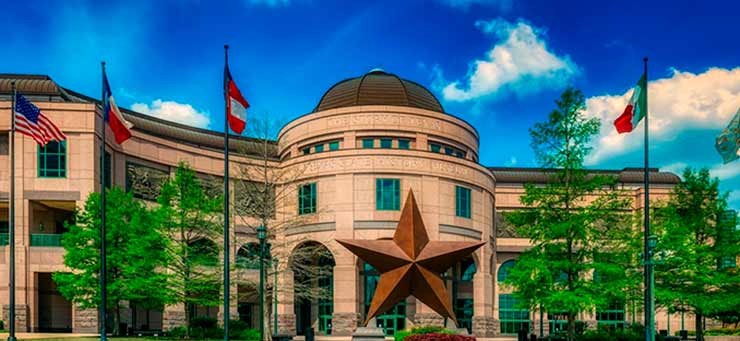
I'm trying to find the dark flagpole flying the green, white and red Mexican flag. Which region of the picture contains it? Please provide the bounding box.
[638,57,655,341]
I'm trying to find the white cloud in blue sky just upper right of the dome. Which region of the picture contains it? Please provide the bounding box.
[437,19,580,101]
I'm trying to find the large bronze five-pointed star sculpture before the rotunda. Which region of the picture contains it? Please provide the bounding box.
[337,191,485,325]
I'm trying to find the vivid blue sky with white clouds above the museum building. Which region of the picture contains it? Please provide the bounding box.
[0,0,740,209]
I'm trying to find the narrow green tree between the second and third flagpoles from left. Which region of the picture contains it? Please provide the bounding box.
[156,163,223,330]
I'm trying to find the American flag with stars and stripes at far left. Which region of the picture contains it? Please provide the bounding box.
[15,94,67,146]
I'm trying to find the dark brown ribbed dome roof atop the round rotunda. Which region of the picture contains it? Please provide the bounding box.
[314,69,444,112]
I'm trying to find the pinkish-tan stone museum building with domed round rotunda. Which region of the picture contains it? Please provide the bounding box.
[0,69,694,337]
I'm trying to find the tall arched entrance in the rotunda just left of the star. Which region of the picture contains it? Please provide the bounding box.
[290,241,335,335]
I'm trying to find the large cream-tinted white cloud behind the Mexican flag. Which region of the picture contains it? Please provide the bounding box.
[586,67,740,165]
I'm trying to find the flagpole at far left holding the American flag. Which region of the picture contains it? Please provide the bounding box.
[8,82,16,341]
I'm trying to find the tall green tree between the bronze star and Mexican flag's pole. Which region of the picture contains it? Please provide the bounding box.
[505,88,636,340]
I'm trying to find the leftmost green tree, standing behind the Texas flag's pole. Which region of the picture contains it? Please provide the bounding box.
[53,187,170,335]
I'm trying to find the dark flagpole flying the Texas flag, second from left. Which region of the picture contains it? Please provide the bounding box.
[99,62,108,341]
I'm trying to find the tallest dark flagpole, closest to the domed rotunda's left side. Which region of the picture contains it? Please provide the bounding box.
[224,45,230,341]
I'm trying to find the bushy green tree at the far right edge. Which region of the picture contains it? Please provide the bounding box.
[655,168,740,340]
